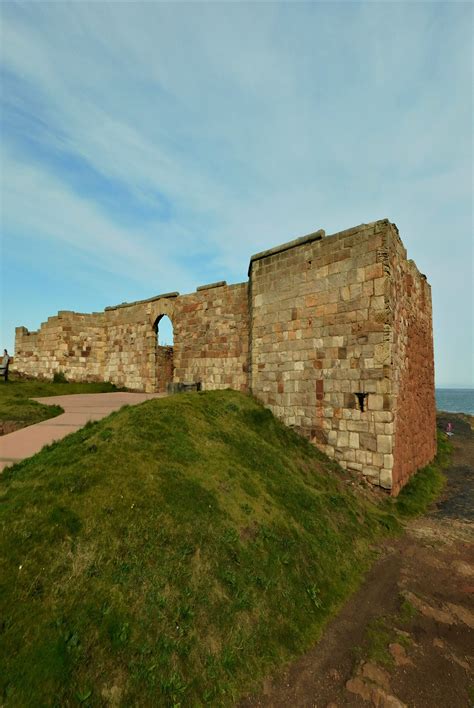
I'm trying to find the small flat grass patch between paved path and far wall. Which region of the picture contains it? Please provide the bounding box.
[0,377,117,427]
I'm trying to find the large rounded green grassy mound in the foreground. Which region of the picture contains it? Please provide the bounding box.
[0,391,444,706]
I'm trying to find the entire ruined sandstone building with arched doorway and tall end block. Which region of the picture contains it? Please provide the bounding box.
[14,219,436,494]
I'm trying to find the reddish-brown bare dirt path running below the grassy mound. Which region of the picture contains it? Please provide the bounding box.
[241,414,474,708]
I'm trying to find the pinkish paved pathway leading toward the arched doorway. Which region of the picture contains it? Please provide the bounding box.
[0,393,166,471]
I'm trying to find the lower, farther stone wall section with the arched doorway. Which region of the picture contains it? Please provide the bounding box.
[14,282,249,392]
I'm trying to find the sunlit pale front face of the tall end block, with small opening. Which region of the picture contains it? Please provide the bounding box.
[251,221,393,488]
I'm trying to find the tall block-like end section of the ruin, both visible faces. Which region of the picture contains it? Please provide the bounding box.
[250,220,435,491]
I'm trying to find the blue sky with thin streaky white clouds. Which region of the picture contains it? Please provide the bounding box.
[0,1,474,387]
